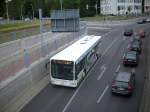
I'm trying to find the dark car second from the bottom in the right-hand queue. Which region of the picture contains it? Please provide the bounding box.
[123,51,139,66]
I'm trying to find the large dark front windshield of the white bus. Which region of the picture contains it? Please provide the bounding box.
[51,60,73,80]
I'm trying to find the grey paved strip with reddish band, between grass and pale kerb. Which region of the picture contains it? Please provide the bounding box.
[0,32,72,82]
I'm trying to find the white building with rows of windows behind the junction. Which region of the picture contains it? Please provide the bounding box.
[101,0,142,15]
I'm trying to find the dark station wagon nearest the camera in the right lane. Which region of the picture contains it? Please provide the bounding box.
[111,72,135,95]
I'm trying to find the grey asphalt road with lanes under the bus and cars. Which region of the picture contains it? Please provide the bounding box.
[21,20,150,112]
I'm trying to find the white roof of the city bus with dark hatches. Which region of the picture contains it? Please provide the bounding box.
[51,35,101,63]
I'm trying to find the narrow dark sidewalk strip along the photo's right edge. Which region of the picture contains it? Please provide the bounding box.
[139,32,150,112]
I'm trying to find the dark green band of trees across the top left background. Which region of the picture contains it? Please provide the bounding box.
[0,0,99,19]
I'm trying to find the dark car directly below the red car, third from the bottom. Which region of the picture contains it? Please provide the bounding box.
[128,41,142,54]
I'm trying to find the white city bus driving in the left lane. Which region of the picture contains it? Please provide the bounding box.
[50,35,101,87]
